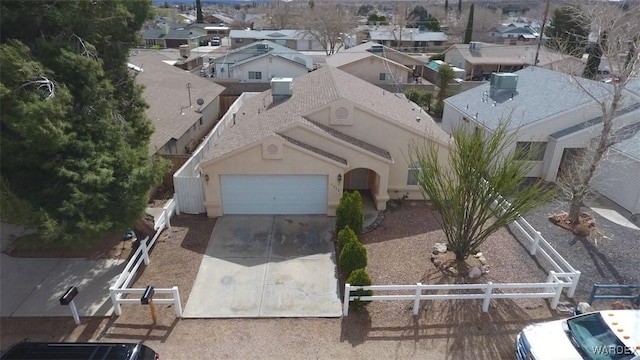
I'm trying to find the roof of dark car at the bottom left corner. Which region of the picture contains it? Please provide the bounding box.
[0,341,160,360]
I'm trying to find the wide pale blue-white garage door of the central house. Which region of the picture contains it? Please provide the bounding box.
[220,175,327,215]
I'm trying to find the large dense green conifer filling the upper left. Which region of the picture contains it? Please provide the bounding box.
[0,0,164,244]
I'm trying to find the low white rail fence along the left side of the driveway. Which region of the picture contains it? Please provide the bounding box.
[109,198,182,317]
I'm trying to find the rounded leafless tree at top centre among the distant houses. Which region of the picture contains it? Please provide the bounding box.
[302,4,355,55]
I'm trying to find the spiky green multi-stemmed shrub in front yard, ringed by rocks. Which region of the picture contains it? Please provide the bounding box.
[409,122,550,261]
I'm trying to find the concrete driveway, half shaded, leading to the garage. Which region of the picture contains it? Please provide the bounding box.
[184,215,342,318]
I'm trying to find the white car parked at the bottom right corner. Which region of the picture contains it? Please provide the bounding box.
[515,310,640,360]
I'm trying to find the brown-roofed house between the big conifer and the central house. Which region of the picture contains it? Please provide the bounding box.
[129,51,224,155]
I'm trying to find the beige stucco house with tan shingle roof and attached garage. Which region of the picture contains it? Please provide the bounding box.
[198,66,450,217]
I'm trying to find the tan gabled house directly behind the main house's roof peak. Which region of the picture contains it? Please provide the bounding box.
[326,42,430,92]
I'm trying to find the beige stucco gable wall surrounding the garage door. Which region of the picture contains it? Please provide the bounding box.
[201,138,344,217]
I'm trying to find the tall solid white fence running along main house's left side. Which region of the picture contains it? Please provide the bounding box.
[173,92,259,214]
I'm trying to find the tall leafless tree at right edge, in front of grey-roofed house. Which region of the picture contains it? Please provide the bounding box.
[558,1,640,226]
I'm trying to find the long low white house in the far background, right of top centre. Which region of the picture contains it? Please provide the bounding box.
[369,28,449,52]
